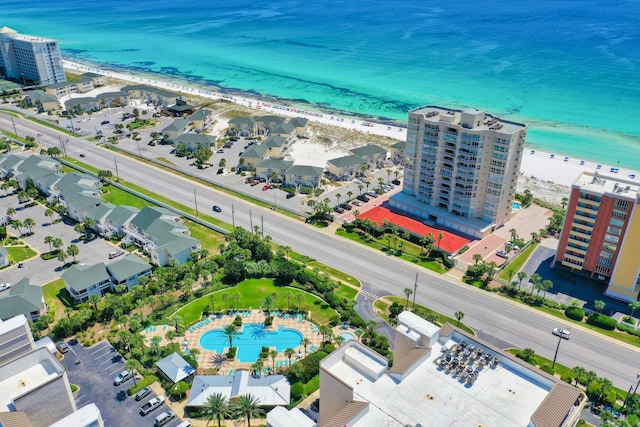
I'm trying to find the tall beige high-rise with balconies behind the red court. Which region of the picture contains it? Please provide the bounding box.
[390,106,527,238]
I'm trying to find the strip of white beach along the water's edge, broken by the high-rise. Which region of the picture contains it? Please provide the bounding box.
[63,59,640,195]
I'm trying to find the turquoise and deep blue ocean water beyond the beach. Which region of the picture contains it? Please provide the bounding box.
[0,0,640,169]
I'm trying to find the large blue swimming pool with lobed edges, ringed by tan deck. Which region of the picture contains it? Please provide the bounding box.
[200,323,303,362]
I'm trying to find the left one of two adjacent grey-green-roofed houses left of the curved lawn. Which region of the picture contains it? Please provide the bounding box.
[62,262,113,303]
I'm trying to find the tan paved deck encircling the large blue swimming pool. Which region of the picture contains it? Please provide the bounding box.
[141,310,355,375]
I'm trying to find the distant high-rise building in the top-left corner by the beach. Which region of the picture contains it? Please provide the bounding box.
[0,27,66,85]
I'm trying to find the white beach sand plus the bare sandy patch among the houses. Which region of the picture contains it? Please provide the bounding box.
[63,60,640,197]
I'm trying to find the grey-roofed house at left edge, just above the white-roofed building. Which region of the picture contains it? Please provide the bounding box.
[0,277,47,322]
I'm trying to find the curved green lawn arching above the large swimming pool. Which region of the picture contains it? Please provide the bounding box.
[172,279,338,326]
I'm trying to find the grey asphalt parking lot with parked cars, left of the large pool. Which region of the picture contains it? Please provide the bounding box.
[62,340,181,427]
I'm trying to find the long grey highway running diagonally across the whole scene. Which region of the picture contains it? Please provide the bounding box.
[0,114,640,388]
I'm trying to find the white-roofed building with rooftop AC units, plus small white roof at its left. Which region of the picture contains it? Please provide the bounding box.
[267,311,587,427]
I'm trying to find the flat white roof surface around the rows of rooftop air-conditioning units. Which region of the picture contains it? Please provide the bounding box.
[322,331,554,427]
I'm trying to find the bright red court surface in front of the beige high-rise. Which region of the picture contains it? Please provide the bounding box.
[358,206,469,254]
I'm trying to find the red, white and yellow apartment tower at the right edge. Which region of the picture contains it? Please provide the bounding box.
[555,171,640,301]
